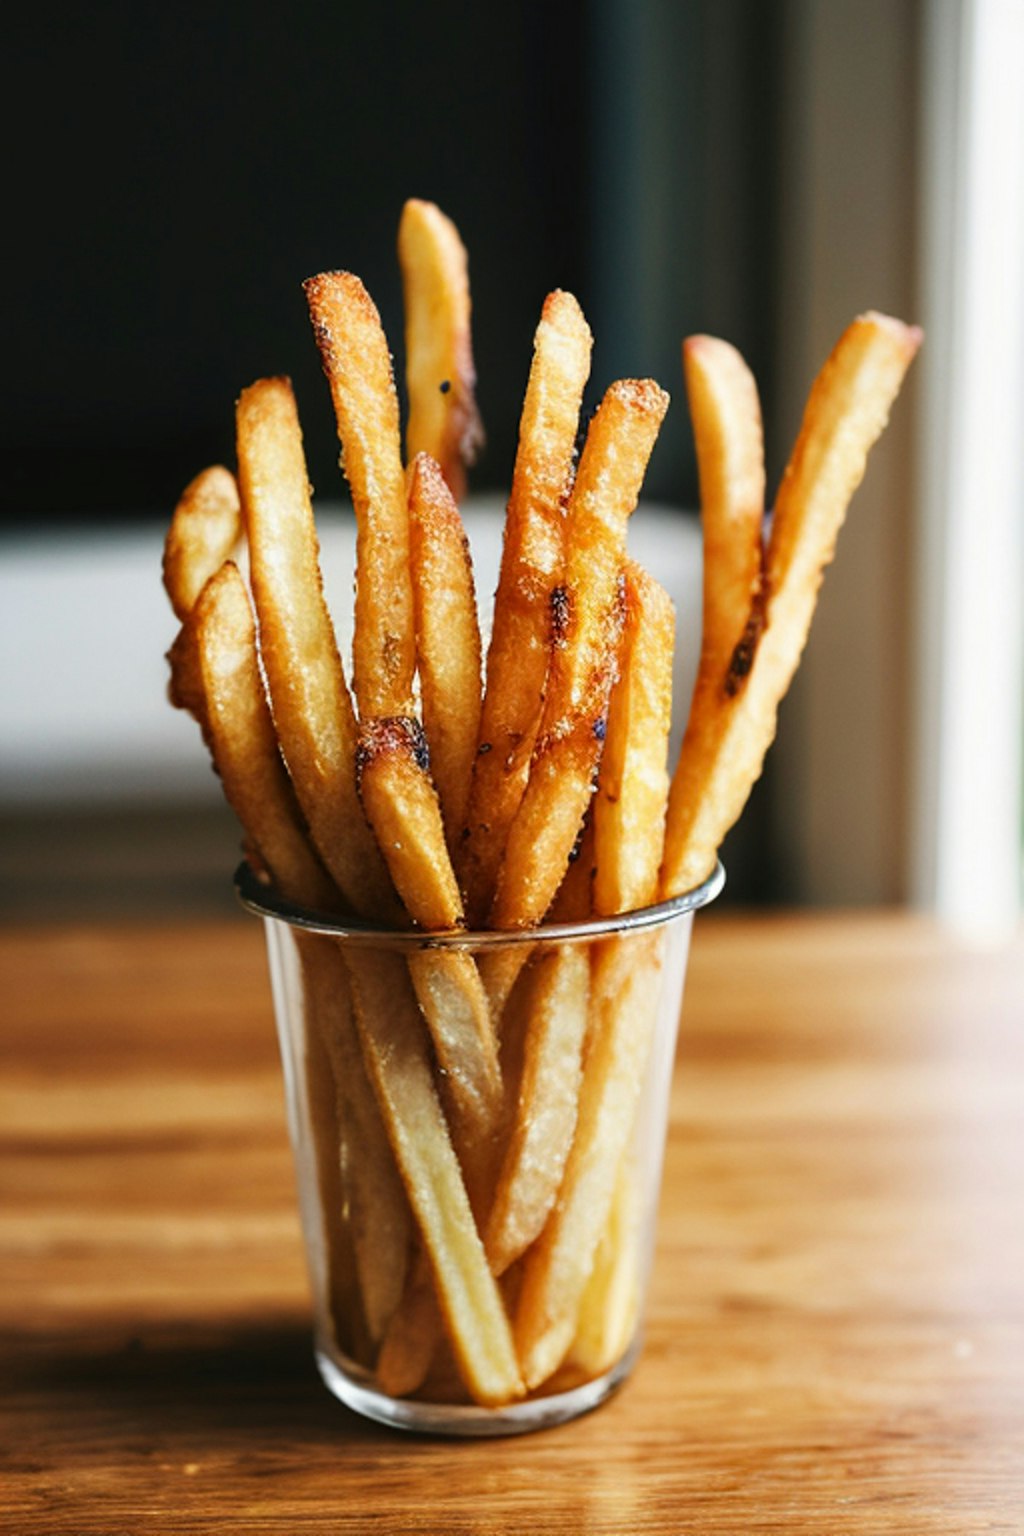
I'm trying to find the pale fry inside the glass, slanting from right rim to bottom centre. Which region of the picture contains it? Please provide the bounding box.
[514,932,663,1389]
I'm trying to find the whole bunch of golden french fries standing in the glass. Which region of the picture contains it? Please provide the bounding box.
[164,201,920,1407]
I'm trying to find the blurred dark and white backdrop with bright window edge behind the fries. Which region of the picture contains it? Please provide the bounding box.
[0,0,1024,934]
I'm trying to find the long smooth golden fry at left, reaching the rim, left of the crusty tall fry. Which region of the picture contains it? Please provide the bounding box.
[238,379,398,917]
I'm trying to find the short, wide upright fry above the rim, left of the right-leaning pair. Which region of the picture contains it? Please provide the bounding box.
[593,561,676,917]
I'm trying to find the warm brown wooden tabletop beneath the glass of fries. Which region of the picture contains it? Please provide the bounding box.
[0,914,1024,1536]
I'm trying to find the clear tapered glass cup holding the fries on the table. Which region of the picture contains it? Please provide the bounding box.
[236,865,725,1435]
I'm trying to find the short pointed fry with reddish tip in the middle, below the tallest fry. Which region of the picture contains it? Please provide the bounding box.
[408,453,481,852]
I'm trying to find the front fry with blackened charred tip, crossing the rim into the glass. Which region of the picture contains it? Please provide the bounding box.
[358,720,502,1143]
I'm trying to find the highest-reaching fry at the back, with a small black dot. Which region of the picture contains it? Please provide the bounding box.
[398,198,484,501]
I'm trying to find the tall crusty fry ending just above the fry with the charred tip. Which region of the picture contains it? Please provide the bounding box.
[302,272,416,720]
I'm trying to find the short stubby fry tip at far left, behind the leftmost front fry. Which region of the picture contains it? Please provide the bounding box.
[163,464,243,624]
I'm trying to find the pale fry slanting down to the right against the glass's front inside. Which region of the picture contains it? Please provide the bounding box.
[348,949,522,1404]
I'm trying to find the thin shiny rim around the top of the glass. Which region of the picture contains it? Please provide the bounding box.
[235,859,725,951]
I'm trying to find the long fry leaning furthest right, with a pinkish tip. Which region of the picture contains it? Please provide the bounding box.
[662,313,921,895]
